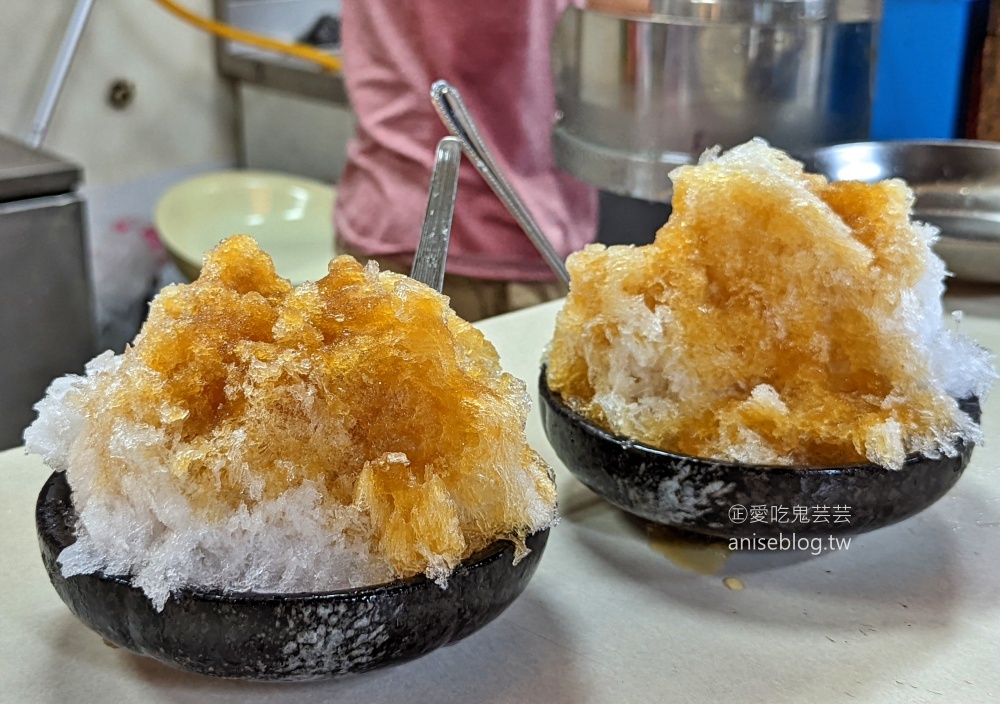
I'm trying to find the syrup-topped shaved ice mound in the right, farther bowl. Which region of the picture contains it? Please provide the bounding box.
[546,140,995,469]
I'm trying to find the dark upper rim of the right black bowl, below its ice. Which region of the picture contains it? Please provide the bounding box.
[538,364,978,476]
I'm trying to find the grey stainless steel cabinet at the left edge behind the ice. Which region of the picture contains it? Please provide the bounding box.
[0,137,96,449]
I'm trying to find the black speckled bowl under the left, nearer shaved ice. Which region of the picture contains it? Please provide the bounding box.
[35,473,548,681]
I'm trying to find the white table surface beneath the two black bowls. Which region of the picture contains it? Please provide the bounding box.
[0,288,1000,704]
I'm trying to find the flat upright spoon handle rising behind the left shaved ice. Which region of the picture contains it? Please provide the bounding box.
[410,137,462,292]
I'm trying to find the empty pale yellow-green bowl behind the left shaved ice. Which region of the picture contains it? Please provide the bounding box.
[153,171,336,285]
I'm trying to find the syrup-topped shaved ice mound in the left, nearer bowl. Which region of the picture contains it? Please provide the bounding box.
[25,236,556,609]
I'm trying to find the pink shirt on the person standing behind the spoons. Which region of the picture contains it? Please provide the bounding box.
[334,0,597,281]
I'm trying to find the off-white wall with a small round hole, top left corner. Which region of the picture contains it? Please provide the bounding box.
[0,0,236,184]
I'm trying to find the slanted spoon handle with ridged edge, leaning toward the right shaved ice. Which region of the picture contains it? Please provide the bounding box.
[431,81,569,283]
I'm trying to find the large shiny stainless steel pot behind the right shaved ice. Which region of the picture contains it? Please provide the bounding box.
[553,0,882,201]
